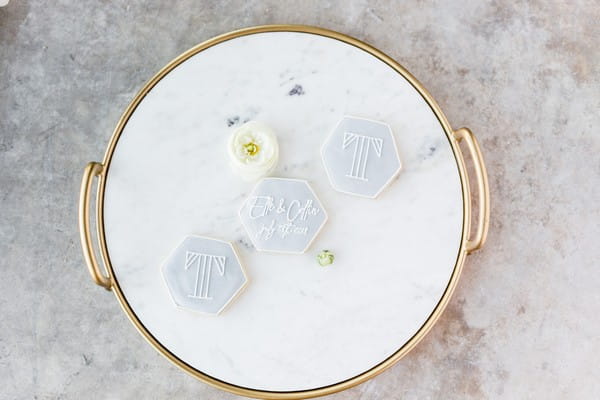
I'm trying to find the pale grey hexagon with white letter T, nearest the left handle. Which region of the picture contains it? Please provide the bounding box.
[162,236,247,314]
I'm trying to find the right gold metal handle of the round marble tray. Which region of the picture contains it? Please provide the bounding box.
[454,128,490,253]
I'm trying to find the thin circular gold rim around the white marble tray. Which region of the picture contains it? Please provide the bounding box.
[91,24,476,399]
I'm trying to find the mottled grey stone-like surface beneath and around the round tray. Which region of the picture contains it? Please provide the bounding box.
[0,0,600,399]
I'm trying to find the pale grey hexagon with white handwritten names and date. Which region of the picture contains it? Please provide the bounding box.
[240,178,327,253]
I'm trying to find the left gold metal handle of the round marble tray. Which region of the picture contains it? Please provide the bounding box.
[79,162,112,290]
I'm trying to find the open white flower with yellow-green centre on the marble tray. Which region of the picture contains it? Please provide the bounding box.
[227,121,279,181]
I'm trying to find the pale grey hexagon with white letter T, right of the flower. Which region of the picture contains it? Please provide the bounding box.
[321,116,401,198]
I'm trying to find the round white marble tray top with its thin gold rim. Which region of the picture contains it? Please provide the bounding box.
[82,26,490,398]
